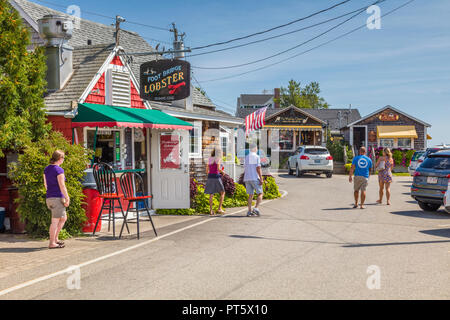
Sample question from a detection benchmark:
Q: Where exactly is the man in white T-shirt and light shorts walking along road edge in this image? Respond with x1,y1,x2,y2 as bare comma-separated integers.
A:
244,144,264,217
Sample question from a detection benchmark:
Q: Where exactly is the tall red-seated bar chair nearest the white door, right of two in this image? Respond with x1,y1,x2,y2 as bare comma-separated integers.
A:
119,172,158,239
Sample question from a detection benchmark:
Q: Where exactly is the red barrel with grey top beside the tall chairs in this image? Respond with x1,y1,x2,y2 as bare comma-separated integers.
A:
81,169,102,232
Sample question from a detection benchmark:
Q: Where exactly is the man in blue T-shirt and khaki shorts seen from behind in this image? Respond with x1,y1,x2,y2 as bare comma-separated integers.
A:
349,147,373,209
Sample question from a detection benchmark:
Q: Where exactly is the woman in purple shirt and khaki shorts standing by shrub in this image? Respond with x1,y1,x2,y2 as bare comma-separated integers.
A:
44,150,70,249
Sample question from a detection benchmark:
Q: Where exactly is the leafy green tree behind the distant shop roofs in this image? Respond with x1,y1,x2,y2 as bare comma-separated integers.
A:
275,79,329,109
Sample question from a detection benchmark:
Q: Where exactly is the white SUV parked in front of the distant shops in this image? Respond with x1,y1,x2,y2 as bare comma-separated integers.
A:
287,146,334,178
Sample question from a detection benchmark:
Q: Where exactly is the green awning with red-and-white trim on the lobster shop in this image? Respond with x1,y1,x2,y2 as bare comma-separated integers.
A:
72,103,193,130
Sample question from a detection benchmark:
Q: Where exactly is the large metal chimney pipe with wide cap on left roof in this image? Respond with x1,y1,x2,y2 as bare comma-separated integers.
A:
38,15,73,92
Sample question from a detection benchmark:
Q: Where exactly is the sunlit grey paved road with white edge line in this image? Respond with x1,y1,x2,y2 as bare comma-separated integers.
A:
0,175,450,299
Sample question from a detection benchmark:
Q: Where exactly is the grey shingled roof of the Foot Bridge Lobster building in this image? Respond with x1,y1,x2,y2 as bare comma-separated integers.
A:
11,0,215,111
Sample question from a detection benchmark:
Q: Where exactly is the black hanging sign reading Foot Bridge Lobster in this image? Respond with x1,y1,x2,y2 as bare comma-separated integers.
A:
141,60,191,102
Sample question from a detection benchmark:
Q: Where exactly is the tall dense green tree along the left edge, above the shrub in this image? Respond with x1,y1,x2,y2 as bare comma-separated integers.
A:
0,0,51,157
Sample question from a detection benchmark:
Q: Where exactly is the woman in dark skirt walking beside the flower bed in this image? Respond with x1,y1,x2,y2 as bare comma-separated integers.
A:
205,149,225,215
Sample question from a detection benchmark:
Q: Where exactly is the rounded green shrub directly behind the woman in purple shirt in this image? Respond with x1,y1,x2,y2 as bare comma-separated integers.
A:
10,131,90,237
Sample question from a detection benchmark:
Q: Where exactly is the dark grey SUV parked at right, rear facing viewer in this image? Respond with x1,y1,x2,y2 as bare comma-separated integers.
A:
411,150,450,211
